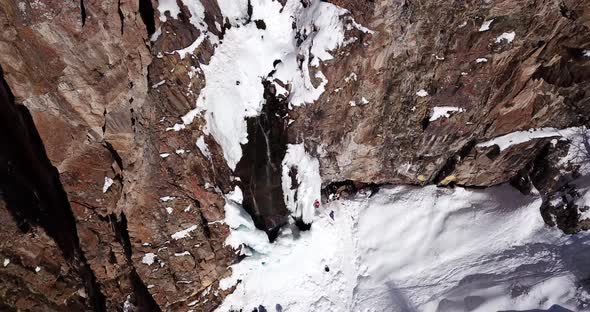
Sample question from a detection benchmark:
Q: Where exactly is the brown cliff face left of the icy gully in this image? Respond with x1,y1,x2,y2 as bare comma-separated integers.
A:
0,1,235,311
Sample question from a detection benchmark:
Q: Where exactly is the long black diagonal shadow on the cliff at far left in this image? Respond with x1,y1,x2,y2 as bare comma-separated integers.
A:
0,68,106,311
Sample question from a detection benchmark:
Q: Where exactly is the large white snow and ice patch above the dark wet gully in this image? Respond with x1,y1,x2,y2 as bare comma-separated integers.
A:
177,0,358,169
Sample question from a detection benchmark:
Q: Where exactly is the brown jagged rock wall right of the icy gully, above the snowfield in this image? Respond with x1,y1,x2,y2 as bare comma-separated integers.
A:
290,0,590,190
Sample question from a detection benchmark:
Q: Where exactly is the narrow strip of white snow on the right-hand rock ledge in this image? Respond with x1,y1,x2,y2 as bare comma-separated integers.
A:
477,128,577,151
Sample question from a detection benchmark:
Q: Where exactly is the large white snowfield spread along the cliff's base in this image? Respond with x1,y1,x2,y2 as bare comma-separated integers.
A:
217,185,590,312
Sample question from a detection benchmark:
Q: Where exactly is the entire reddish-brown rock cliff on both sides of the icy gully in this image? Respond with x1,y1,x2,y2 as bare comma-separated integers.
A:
0,0,590,311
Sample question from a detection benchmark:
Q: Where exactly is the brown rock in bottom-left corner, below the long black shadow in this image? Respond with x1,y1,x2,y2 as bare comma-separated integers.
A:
0,203,88,311
